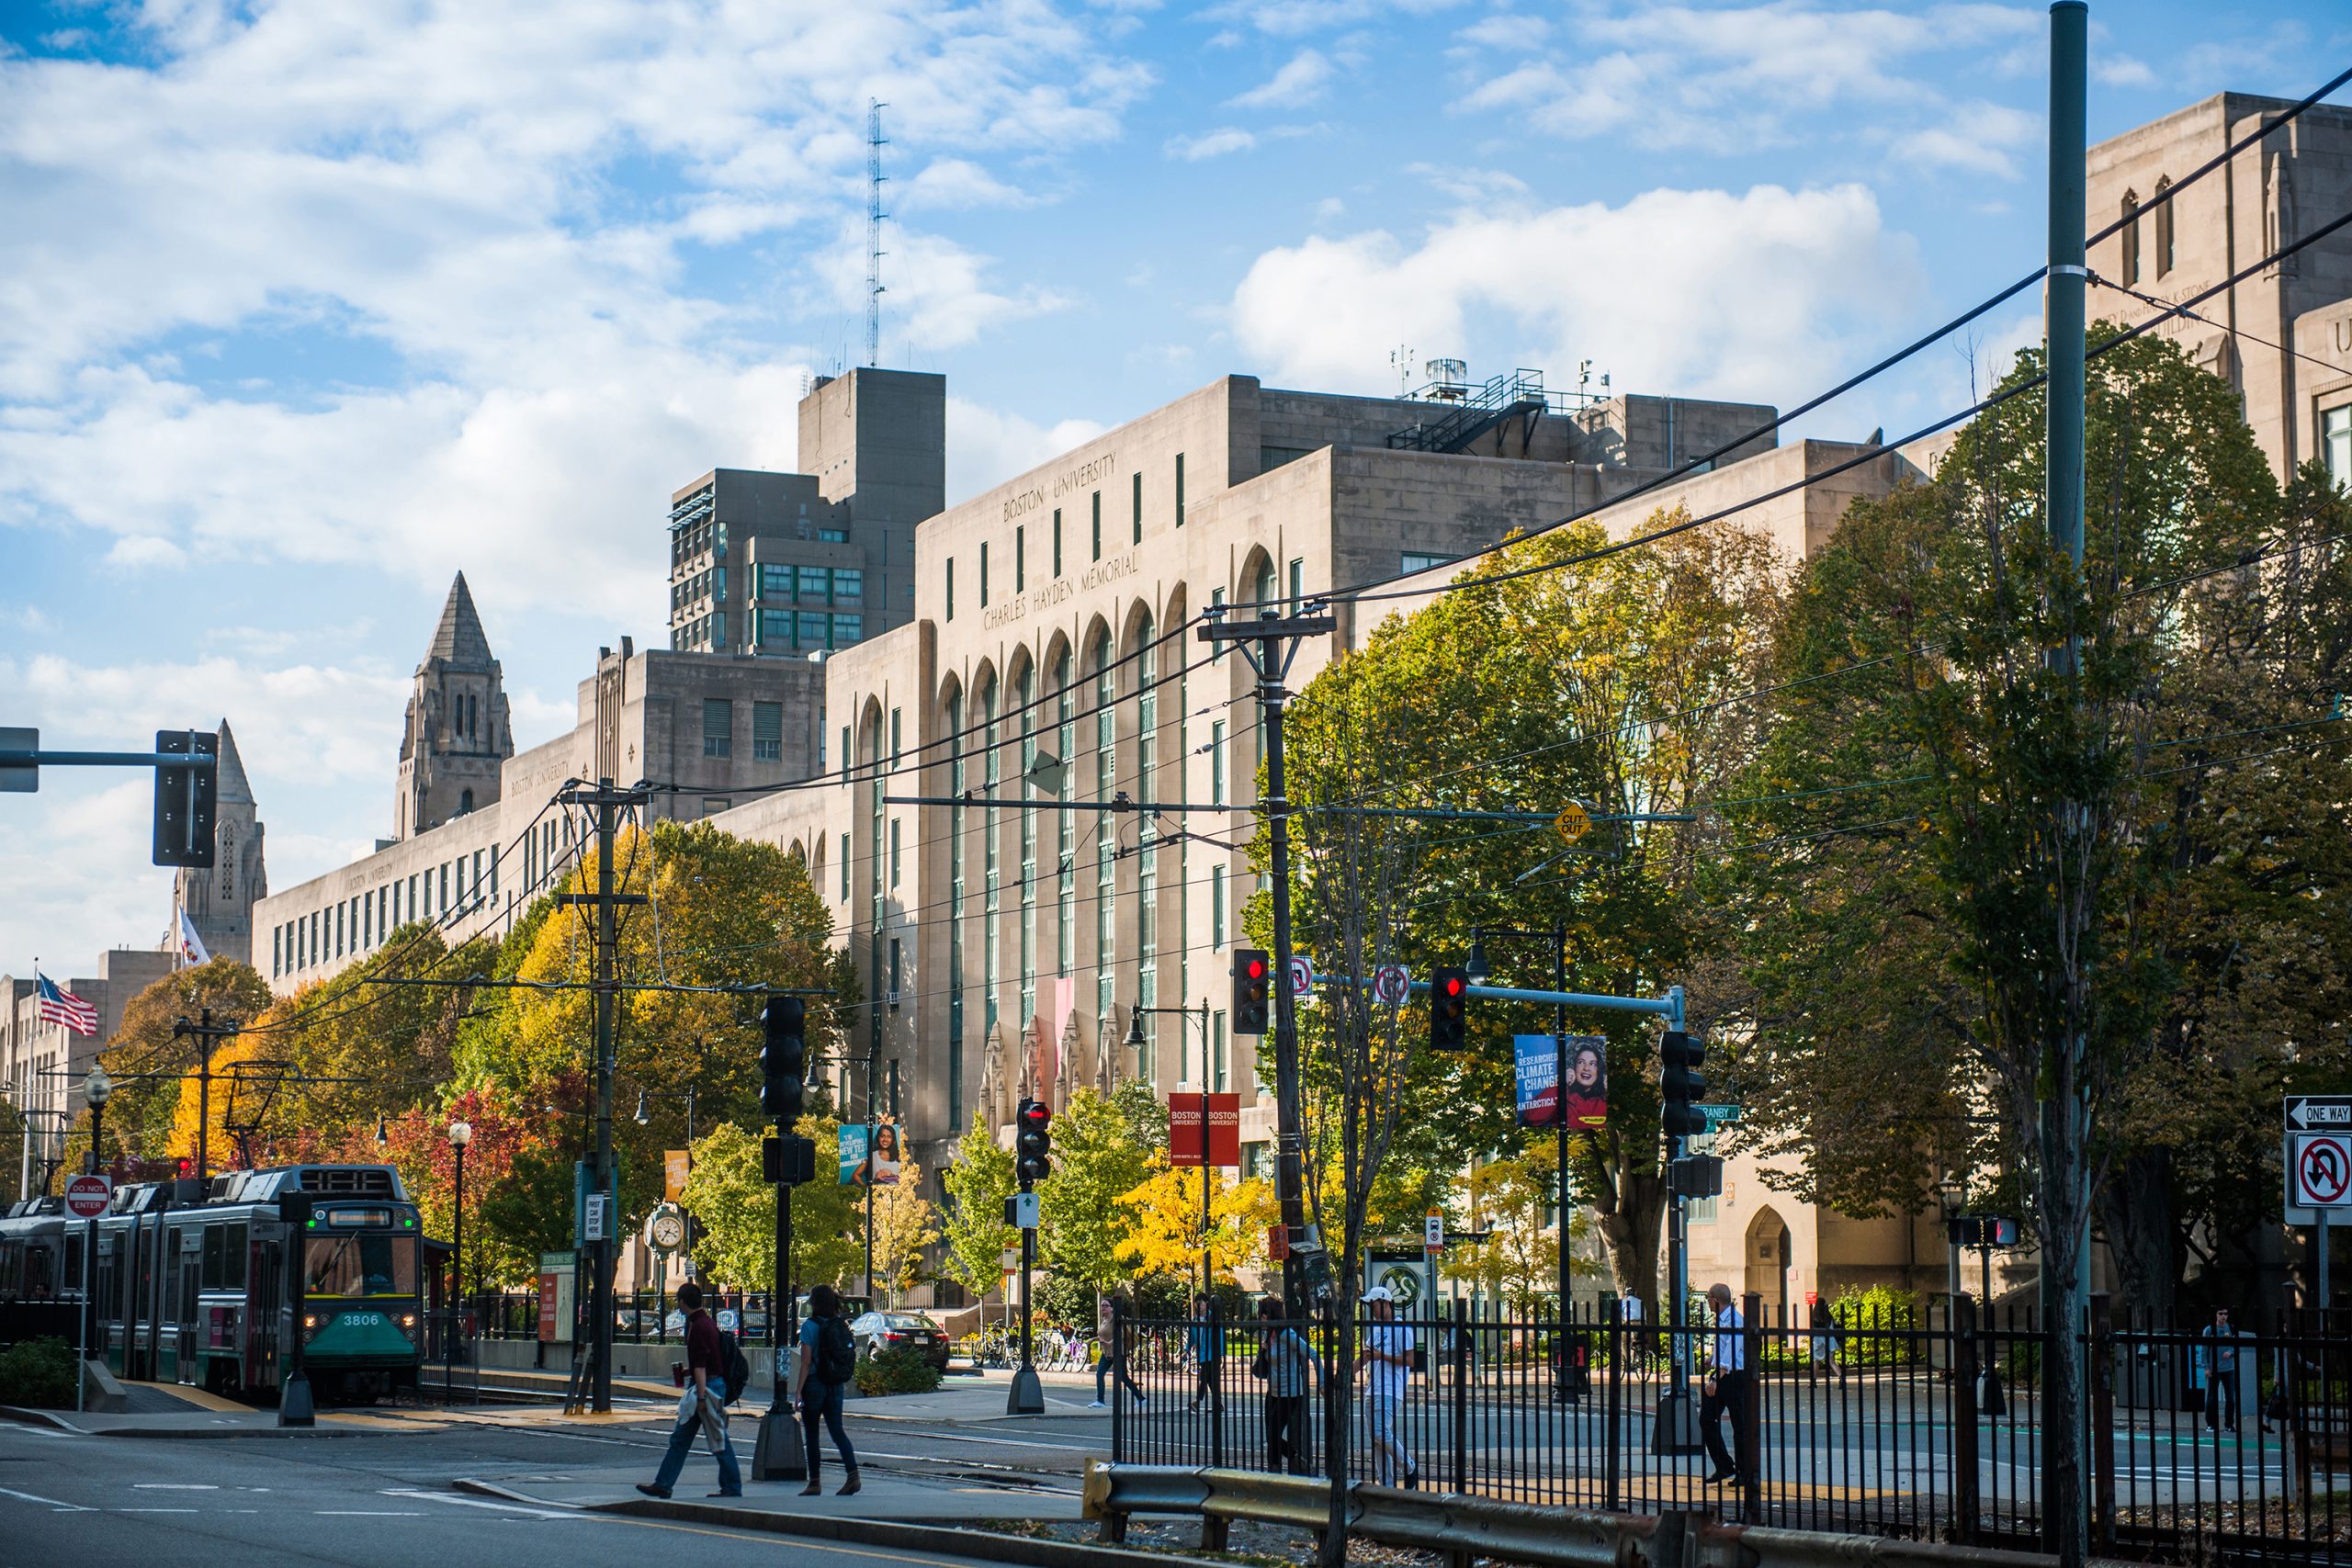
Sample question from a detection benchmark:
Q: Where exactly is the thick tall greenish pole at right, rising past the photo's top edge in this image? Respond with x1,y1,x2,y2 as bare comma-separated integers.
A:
2041,12,2091,1568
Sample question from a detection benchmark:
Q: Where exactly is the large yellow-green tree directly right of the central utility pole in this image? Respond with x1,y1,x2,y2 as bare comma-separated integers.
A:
1288,514,1782,1298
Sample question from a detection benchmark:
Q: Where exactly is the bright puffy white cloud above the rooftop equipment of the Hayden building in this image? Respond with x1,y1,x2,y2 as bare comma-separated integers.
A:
1230,186,1922,402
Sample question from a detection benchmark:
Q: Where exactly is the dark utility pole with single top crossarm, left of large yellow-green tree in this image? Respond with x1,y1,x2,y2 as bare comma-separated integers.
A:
1200,604,1339,1316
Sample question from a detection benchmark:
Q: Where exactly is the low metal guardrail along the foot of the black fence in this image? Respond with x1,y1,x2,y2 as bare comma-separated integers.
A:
1084,1462,2051,1568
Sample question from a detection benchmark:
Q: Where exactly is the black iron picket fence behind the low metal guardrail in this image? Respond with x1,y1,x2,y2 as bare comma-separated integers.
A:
1099,1298,2352,1563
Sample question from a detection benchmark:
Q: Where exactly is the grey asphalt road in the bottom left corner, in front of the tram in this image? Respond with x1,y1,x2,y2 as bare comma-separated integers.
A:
0,1422,1068,1568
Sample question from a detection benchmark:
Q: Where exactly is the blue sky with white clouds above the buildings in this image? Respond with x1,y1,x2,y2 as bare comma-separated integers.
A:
0,0,2352,974
